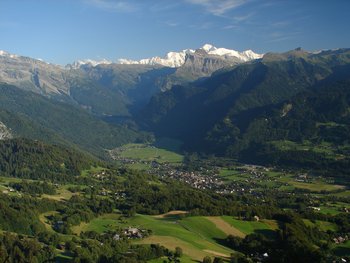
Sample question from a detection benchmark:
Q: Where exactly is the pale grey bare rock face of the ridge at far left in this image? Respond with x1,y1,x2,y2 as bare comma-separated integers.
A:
0,51,69,95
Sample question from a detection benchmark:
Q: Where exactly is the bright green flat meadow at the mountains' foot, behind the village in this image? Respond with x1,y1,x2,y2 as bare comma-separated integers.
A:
119,143,183,163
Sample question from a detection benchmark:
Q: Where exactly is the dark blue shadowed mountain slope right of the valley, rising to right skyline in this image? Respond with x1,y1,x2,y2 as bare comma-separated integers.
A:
139,49,350,157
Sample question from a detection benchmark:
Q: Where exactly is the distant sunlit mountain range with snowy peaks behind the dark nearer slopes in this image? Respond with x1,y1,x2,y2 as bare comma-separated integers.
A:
0,44,262,117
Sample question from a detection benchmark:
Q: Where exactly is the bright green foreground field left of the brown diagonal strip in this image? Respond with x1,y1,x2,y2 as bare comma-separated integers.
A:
72,215,234,262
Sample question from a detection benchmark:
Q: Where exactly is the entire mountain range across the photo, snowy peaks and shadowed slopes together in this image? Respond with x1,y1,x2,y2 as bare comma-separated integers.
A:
0,44,350,175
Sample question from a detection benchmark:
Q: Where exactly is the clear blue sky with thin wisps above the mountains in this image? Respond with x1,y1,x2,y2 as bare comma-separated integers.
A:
0,0,350,65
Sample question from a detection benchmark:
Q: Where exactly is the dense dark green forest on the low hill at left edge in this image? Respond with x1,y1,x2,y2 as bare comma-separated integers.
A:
0,139,97,181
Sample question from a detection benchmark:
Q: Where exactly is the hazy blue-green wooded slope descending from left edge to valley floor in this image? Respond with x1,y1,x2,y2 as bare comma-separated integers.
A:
0,84,147,156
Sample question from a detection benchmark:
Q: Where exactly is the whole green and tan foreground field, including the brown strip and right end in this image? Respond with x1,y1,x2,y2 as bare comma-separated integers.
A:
72,212,277,262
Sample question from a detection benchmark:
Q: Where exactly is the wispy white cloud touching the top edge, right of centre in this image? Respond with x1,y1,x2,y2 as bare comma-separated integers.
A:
185,0,247,16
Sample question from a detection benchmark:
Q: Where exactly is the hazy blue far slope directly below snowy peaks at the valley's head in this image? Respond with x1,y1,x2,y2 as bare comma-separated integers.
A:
70,64,174,116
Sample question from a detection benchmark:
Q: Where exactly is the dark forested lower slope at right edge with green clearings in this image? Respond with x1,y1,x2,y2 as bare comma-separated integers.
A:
238,80,350,177
